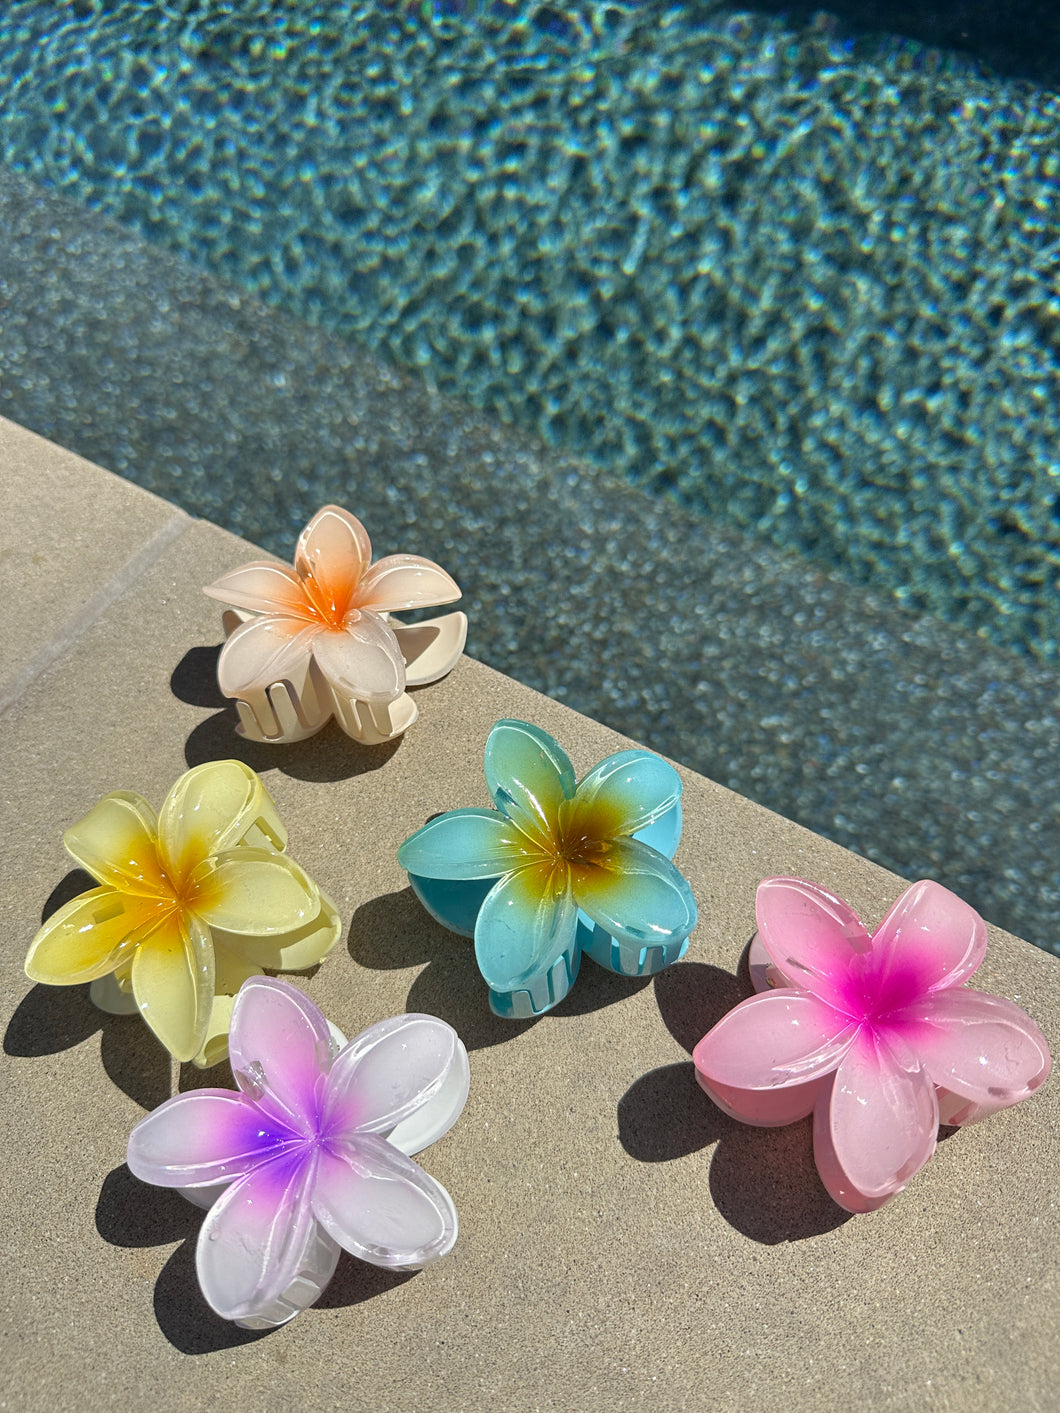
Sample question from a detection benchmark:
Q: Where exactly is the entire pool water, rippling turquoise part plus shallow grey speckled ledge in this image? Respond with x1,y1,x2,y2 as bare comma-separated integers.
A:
0,0,1060,944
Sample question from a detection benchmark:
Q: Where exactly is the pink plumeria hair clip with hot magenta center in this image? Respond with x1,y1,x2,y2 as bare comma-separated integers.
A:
693,877,1052,1212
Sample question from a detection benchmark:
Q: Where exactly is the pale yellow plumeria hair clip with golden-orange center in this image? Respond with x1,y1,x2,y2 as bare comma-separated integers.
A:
25,760,341,1065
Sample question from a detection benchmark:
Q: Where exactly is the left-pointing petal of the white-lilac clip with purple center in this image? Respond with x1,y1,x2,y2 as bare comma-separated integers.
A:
127,1089,299,1187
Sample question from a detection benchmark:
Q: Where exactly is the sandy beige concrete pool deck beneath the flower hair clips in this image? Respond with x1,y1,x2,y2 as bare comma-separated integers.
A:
0,421,1060,1413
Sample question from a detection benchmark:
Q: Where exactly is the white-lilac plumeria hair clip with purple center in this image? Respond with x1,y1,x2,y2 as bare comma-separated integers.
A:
129,976,468,1330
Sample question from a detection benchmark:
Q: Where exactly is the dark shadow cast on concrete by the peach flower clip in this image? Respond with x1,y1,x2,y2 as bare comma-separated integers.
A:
170,643,401,784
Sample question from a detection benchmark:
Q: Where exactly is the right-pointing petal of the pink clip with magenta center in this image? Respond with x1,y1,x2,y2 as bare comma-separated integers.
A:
902,986,1052,1123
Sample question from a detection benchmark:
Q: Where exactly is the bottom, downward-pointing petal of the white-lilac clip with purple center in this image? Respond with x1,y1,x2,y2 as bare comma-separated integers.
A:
195,1152,317,1320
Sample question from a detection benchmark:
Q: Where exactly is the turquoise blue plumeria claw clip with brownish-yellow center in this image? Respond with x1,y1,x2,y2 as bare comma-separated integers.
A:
397,721,697,1020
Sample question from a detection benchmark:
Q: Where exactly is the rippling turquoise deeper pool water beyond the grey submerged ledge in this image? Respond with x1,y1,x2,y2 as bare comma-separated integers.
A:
0,0,1060,661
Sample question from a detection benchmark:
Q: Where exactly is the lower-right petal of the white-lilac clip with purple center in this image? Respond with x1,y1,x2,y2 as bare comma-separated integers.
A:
312,1133,457,1267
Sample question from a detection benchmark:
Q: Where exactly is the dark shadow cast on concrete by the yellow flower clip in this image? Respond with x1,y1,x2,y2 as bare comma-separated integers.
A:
4,869,170,1109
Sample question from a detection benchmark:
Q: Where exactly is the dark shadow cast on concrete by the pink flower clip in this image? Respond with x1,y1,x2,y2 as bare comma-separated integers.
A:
618,950,849,1245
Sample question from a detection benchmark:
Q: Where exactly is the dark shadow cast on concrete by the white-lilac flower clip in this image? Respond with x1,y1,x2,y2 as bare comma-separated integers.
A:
96,1163,417,1354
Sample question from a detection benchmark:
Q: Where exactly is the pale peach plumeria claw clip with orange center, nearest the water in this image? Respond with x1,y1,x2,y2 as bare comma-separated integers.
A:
204,506,468,746
